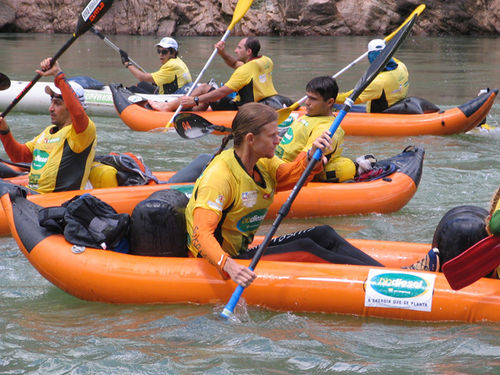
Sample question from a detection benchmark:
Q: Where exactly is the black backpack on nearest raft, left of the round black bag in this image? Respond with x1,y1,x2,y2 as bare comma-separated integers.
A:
38,193,130,252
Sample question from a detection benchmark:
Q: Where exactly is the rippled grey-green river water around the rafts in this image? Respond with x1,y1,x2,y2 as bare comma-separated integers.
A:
0,33,500,374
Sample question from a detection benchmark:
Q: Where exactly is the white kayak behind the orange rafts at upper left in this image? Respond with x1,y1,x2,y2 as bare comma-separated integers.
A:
0,78,180,117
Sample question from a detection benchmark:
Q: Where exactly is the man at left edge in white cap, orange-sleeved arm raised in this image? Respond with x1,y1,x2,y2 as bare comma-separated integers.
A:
0,58,97,193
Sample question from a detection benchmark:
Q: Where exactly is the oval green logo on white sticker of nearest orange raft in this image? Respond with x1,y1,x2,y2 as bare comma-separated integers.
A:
369,273,429,298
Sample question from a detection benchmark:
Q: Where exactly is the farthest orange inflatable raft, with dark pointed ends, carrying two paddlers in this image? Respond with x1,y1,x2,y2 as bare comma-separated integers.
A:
110,84,498,136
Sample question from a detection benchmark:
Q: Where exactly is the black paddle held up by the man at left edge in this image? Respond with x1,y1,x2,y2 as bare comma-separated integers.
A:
0,0,113,117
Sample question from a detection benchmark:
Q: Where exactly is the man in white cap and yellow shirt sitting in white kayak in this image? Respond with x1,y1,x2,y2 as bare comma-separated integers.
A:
120,37,192,94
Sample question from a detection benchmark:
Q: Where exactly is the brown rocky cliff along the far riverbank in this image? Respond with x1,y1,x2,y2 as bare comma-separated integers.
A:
0,0,500,36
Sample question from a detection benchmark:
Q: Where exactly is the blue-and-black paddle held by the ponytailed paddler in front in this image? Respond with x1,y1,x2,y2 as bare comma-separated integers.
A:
220,8,418,319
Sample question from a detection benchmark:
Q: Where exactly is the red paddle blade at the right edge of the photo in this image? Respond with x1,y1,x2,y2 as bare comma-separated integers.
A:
441,236,500,290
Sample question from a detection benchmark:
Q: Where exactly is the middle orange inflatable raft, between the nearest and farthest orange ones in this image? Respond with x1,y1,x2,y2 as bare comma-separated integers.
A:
0,146,425,235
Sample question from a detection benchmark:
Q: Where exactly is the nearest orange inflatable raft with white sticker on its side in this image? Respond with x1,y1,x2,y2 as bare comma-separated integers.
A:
1,194,500,322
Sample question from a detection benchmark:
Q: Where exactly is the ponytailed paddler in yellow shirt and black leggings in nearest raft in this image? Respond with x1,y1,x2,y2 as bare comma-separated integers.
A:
186,103,382,287
